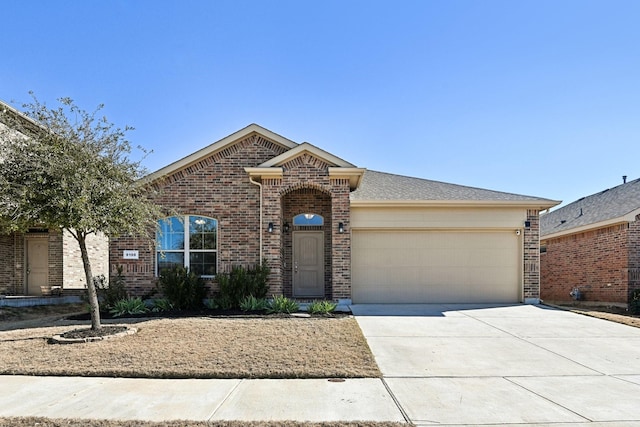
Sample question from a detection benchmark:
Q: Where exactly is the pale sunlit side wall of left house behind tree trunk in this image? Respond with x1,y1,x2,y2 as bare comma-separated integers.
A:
62,231,109,289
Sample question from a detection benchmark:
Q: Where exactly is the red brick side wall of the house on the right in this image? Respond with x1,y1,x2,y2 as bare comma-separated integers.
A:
540,222,640,304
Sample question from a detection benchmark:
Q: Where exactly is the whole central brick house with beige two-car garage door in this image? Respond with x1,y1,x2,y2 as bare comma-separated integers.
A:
110,124,559,303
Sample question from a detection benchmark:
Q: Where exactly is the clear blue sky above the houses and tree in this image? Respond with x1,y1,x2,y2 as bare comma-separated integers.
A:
0,0,640,207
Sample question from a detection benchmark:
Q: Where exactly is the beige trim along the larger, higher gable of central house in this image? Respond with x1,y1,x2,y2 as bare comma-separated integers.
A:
144,123,298,181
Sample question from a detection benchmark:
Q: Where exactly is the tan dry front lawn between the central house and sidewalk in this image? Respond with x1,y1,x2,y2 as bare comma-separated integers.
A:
0,317,381,378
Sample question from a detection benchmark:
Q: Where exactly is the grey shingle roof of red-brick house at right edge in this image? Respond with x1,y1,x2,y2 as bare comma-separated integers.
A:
540,179,640,238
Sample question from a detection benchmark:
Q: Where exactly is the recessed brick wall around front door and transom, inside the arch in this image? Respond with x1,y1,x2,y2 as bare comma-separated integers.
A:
281,184,333,299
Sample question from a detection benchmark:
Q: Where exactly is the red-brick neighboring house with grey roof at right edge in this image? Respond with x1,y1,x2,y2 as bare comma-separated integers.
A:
540,177,640,305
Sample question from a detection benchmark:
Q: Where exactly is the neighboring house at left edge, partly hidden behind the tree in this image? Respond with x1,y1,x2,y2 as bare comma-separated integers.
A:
0,101,109,296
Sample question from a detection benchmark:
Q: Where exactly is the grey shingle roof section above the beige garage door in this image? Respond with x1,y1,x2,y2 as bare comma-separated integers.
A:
351,170,560,209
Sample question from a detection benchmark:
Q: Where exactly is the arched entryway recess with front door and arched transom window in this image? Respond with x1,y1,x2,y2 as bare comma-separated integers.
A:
281,188,332,300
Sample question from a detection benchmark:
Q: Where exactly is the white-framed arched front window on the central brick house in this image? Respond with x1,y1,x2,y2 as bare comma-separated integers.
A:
156,215,218,278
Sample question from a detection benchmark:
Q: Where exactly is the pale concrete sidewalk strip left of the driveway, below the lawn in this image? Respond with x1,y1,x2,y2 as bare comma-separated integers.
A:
0,376,404,422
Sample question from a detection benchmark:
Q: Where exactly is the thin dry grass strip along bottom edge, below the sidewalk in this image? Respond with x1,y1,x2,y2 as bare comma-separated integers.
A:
0,417,408,427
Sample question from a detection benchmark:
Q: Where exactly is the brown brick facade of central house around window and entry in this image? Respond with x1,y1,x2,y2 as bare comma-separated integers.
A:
110,135,351,299
